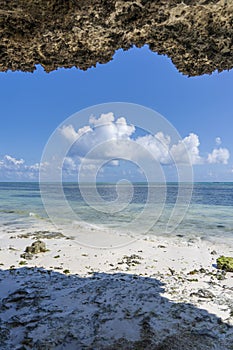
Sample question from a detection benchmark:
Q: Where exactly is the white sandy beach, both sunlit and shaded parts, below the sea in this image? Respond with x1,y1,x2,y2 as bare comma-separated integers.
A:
0,230,233,350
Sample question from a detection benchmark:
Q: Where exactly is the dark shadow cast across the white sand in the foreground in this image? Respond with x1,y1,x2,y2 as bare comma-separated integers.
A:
0,267,233,350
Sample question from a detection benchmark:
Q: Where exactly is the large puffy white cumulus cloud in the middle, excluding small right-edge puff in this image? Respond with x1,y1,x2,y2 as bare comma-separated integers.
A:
61,113,204,164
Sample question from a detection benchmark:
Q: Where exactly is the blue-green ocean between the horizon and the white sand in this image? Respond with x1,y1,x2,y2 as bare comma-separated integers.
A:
0,182,233,242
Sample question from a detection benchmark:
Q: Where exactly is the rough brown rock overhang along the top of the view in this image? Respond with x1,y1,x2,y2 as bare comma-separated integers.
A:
0,0,233,76
